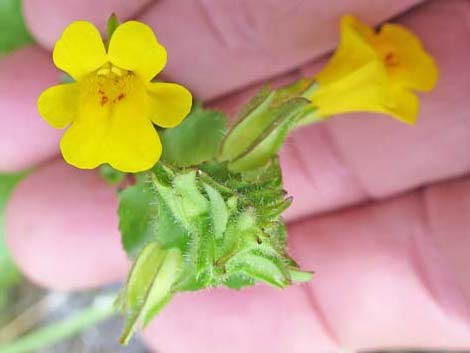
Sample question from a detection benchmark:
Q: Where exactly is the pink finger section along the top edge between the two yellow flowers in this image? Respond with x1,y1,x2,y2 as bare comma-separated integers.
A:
141,0,420,100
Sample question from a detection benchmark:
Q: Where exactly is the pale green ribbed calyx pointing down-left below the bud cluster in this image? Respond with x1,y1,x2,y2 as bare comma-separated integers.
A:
119,242,183,344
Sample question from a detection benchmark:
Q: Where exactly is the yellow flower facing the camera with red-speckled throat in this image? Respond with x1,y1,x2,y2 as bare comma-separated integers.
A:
38,21,192,172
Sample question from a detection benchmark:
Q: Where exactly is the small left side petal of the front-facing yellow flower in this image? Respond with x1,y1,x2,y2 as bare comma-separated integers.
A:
38,83,79,129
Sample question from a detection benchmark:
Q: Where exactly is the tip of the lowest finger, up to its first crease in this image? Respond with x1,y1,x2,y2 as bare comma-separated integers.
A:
143,285,336,353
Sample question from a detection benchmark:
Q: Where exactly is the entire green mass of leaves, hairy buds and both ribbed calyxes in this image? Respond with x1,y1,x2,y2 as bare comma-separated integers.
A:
118,83,318,343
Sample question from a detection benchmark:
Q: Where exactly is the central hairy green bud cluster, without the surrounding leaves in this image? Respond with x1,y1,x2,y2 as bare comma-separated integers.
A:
153,161,304,290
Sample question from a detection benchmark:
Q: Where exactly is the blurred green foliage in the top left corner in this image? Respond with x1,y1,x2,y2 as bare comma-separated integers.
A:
0,0,33,54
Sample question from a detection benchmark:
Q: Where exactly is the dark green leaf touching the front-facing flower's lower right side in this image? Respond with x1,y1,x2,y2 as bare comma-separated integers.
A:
161,104,226,167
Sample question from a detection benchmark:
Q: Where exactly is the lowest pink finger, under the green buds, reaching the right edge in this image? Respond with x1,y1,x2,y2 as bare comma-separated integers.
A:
144,179,470,353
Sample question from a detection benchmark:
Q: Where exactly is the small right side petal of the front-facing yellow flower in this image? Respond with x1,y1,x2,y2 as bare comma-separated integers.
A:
147,82,192,128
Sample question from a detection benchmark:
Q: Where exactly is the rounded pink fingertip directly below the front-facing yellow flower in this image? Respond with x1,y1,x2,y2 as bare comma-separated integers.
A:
5,160,129,290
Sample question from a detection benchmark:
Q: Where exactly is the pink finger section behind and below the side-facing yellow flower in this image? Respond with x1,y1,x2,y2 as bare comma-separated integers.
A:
213,1,470,219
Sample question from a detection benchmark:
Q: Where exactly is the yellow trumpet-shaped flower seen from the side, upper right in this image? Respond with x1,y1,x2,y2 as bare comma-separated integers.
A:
308,15,438,124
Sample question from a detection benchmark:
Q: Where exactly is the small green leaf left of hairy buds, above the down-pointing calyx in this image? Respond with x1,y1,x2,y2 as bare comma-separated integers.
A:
118,181,157,258
